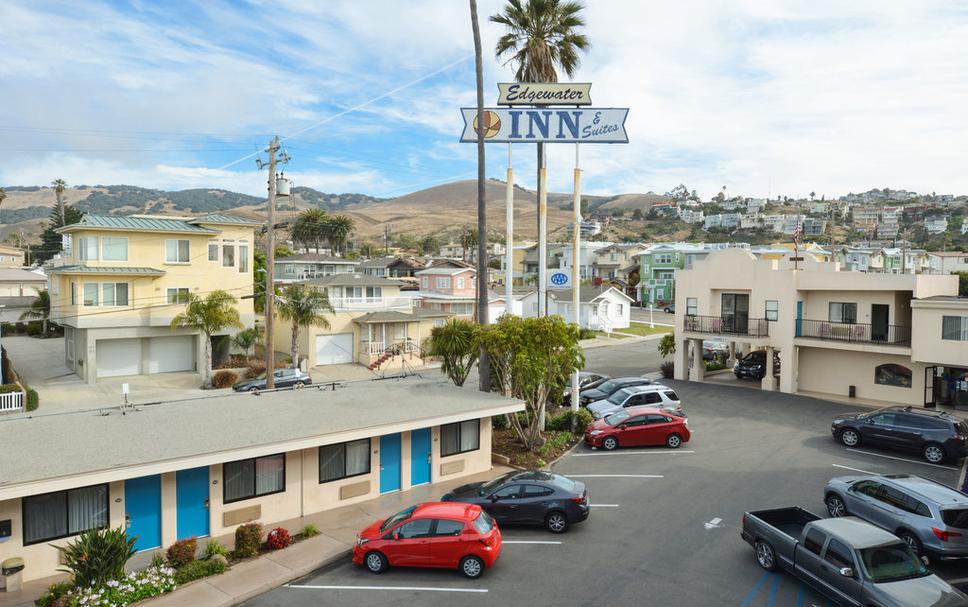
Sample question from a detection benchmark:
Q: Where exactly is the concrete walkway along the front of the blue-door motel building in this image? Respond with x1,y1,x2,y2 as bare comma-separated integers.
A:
0,465,511,607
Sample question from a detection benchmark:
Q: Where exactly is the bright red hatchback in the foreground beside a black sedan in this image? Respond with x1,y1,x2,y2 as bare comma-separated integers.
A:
353,502,501,579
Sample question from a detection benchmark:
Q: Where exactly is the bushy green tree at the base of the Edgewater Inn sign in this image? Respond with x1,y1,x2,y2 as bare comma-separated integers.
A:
480,314,585,449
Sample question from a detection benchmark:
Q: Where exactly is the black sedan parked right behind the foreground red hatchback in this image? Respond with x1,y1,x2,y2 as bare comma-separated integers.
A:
440,470,588,533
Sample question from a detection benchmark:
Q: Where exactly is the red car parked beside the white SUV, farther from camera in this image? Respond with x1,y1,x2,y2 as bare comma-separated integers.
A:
585,407,690,451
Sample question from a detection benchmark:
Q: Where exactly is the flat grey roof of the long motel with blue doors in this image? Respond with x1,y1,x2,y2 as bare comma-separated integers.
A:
0,376,524,501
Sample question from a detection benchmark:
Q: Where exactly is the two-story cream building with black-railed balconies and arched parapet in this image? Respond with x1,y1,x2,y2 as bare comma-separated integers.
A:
675,249,968,407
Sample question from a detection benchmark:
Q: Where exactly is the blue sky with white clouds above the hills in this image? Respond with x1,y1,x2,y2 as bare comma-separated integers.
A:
0,0,968,197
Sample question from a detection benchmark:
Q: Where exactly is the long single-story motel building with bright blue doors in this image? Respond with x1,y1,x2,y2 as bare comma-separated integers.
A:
0,378,524,581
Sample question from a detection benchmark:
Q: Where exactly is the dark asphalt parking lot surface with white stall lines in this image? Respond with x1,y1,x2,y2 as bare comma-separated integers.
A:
247,381,968,607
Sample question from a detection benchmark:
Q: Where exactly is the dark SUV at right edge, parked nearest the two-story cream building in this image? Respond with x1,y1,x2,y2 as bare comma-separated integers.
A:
830,407,968,464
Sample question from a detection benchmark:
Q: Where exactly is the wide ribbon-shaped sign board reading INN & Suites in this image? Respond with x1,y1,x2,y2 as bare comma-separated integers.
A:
460,108,629,143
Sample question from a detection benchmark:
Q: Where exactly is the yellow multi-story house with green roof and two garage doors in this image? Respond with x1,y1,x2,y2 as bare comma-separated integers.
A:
47,215,261,384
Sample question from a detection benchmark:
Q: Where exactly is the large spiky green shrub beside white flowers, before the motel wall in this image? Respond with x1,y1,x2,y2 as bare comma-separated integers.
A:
57,527,135,587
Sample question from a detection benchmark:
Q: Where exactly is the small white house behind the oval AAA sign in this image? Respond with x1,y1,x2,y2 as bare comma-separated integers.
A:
522,286,632,331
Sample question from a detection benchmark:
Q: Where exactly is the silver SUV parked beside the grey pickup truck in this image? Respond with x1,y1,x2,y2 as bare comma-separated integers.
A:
824,474,968,561
